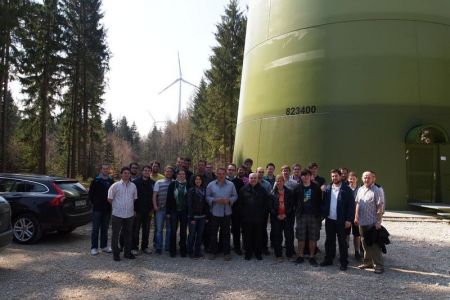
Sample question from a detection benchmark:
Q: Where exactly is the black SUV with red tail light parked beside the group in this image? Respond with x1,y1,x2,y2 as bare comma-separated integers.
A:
0,173,92,244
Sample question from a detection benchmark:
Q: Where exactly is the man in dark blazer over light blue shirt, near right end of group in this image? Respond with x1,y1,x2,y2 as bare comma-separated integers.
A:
320,169,355,271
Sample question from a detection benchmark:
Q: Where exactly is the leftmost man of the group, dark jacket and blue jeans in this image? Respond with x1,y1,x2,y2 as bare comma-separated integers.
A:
89,164,113,255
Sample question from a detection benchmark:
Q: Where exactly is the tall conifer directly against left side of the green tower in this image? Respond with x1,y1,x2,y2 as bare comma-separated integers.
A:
189,0,247,162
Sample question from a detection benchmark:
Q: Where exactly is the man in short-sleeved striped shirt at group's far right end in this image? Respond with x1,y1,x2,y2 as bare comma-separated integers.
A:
355,171,384,274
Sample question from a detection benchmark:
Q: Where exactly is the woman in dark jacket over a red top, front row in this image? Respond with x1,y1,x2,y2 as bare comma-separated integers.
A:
270,175,295,261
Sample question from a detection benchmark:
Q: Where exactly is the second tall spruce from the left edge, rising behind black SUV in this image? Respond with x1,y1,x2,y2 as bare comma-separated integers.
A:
20,0,63,174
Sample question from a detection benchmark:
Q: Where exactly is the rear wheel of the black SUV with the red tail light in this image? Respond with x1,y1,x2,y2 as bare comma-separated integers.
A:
13,214,42,244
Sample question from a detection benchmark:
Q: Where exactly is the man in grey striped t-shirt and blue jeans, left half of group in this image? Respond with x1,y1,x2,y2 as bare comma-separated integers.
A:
153,166,174,254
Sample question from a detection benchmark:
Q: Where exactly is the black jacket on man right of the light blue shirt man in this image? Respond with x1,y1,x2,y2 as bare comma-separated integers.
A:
239,183,270,223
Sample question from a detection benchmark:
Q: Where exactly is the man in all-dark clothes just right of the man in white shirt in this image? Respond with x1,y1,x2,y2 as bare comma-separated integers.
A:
131,166,155,255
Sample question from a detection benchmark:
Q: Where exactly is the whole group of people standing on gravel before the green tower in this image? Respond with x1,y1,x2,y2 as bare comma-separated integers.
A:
89,157,385,273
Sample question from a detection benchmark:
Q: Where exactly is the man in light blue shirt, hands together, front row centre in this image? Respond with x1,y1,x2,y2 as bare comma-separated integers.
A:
206,168,237,260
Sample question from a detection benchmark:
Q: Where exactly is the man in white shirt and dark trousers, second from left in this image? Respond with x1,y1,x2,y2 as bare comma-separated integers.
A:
108,167,137,261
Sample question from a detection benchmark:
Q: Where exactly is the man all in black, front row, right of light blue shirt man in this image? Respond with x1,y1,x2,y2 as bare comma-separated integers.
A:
239,173,269,260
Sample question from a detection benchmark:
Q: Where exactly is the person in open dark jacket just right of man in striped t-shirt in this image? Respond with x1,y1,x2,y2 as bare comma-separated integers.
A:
166,170,188,257
